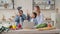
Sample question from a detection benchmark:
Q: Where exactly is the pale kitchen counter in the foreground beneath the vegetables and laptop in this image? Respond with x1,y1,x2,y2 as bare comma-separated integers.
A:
2,29,60,34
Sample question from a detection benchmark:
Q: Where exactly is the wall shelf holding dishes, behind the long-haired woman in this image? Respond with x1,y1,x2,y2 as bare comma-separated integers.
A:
33,0,55,10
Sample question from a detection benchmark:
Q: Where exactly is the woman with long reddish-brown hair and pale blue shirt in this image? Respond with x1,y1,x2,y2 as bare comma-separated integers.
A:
34,6,44,24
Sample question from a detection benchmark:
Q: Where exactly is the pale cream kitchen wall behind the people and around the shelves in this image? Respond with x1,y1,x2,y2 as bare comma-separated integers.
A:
0,0,60,19
